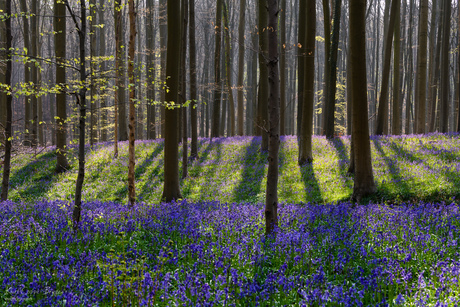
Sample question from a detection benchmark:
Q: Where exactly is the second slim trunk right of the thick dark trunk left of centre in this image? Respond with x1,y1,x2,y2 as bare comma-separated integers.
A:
189,0,198,159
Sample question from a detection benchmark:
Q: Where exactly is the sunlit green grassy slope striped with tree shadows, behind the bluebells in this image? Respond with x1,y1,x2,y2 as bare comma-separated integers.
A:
0,134,460,203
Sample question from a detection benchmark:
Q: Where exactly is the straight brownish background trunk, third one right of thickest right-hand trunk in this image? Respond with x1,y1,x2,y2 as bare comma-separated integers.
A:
414,0,428,134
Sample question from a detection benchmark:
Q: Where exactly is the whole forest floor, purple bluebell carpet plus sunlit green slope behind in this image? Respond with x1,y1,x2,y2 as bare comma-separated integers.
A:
0,134,460,306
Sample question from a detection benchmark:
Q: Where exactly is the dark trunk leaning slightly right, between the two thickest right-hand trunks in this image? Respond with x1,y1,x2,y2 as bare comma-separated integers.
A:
324,0,342,138
